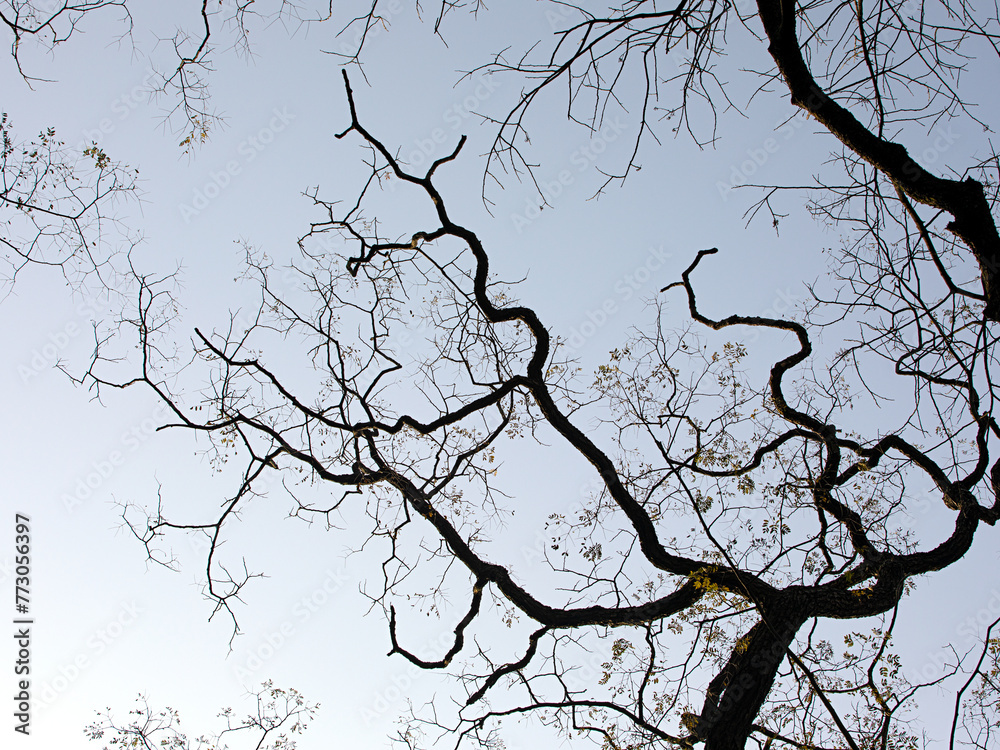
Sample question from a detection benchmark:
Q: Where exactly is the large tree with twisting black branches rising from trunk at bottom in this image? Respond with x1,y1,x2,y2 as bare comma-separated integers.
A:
68,63,1000,750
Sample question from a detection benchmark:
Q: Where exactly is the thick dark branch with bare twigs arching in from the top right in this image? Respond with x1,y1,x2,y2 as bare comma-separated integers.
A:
472,0,1000,321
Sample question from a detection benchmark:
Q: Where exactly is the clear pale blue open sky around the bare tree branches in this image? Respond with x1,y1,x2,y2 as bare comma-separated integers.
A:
0,2,1000,750
